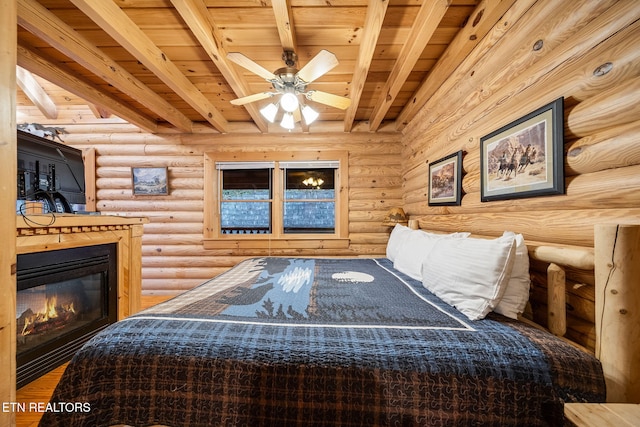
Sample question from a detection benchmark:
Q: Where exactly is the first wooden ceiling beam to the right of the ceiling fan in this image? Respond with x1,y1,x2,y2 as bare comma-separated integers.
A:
344,0,389,132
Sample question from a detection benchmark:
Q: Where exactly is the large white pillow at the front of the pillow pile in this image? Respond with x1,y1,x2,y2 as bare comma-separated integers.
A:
422,236,516,320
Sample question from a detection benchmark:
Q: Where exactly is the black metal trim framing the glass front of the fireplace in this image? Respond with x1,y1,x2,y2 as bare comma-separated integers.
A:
16,243,118,388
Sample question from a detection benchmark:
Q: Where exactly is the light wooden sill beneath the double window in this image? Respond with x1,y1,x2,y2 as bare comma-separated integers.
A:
203,235,349,249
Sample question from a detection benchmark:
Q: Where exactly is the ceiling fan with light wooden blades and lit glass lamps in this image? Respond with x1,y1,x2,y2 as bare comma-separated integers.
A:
227,49,351,130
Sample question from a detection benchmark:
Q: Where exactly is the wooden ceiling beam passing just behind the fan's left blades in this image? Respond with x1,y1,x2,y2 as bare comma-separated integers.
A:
171,0,269,133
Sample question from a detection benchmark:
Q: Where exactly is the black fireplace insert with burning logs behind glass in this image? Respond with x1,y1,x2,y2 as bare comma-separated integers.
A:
16,243,118,387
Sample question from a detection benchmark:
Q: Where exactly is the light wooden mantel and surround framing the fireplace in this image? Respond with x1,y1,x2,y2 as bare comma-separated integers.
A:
16,214,149,319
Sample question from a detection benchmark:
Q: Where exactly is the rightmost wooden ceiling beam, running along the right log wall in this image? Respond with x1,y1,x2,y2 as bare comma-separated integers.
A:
396,0,515,130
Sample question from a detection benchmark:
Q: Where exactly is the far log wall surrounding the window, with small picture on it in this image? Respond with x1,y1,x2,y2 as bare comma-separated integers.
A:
65,132,402,295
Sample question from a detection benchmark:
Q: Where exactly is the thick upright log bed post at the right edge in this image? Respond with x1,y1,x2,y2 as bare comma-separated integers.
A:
594,225,640,403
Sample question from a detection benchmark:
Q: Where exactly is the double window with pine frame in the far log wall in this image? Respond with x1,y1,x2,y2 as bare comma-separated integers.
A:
204,152,348,248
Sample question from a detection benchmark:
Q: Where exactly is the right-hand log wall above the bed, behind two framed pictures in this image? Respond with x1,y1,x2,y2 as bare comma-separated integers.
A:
402,0,640,348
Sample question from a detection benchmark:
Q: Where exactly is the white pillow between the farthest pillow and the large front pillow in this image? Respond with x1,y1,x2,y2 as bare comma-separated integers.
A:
393,230,447,280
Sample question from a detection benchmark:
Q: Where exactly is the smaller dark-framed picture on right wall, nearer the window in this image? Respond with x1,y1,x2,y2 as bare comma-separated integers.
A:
428,150,463,206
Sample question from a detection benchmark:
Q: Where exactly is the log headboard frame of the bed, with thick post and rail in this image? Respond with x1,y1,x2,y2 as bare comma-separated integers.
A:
440,224,640,403
